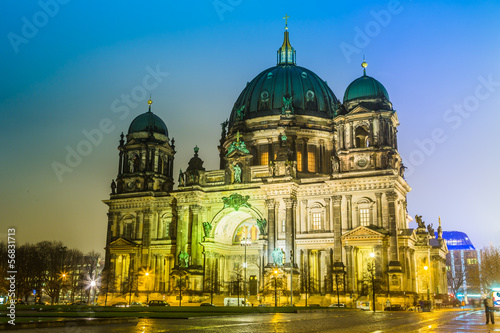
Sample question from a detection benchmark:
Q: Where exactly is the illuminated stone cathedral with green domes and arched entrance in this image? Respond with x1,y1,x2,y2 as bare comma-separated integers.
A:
104,24,447,303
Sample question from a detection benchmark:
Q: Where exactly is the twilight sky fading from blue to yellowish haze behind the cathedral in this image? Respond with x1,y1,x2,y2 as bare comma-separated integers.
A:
0,0,500,253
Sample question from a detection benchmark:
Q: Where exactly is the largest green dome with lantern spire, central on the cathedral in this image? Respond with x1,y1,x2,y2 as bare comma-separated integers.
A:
229,30,339,126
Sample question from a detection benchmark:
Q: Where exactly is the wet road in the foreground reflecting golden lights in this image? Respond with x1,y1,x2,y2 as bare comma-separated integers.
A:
13,310,500,333
